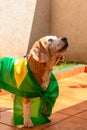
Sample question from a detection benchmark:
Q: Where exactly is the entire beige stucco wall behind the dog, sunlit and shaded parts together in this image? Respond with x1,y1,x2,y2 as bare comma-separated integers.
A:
0,0,87,62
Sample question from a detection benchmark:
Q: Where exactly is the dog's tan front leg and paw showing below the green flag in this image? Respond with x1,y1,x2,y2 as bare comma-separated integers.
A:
23,98,33,127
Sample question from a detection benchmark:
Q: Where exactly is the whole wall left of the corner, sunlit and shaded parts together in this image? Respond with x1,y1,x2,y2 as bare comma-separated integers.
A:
0,0,50,56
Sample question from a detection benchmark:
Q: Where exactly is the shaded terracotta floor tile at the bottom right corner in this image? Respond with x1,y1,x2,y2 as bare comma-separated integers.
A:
45,117,87,130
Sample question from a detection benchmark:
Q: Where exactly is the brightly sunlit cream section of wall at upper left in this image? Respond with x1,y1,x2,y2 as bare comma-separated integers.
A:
0,0,36,56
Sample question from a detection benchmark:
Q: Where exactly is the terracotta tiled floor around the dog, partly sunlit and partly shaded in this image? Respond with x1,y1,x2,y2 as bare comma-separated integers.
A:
0,72,87,130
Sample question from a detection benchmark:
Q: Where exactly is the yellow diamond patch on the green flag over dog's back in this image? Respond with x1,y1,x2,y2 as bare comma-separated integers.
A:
14,58,28,87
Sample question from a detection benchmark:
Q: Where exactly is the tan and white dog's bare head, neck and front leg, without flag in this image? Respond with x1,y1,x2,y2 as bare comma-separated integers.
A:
0,36,68,127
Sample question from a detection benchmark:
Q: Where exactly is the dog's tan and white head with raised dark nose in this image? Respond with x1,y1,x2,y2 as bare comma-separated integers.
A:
30,36,68,63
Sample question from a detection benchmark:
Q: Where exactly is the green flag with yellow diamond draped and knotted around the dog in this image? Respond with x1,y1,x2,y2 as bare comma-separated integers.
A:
0,57,59,125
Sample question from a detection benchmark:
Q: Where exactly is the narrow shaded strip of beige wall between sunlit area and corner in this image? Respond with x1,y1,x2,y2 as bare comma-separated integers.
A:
28,0,51,50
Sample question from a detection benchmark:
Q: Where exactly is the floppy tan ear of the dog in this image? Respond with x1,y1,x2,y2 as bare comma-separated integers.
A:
30,40,50,63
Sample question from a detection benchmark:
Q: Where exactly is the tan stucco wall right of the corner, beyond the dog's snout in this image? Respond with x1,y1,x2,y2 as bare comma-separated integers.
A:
51,0,87,62
